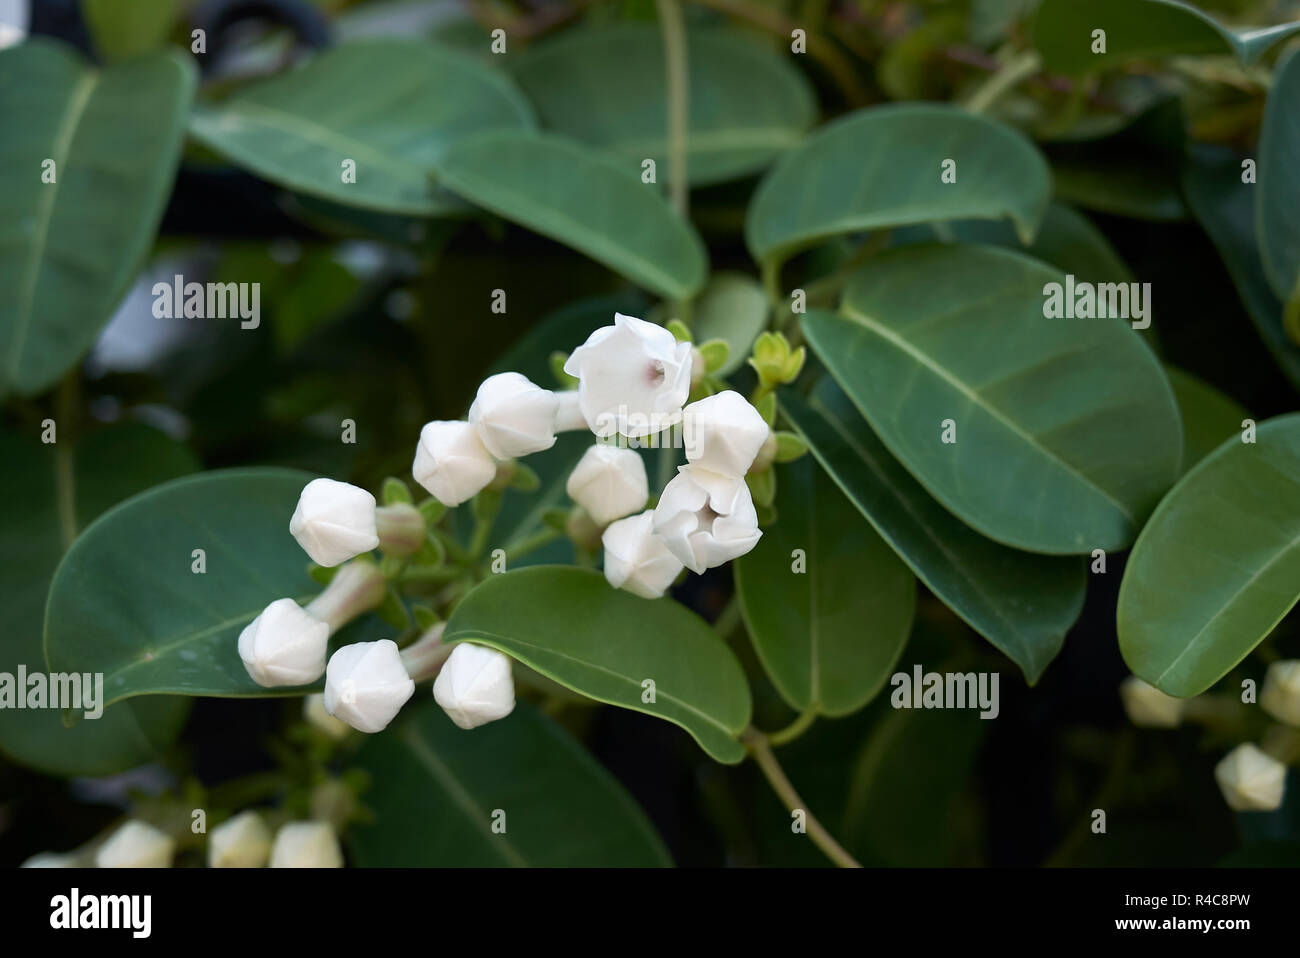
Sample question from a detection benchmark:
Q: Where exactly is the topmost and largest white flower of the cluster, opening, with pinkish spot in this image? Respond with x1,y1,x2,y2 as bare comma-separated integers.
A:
564,313,690,438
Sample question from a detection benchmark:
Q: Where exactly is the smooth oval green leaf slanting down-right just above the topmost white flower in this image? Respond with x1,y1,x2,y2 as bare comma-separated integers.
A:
437,130,707,299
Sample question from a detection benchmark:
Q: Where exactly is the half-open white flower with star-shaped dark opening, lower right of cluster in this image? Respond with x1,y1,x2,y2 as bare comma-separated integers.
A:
654,465,763,575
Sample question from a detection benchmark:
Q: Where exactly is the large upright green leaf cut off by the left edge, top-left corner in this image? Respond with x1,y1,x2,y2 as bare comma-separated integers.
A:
0,38,195,395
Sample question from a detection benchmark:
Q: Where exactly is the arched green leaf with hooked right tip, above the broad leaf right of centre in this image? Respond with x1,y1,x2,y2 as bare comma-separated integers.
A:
745,104,1050,270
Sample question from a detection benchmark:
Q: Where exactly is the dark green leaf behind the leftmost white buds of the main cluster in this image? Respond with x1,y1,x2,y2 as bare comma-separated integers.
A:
46,469,358,703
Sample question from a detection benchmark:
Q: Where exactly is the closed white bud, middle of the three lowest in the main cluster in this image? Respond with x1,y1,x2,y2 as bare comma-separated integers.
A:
325,638,415,733
